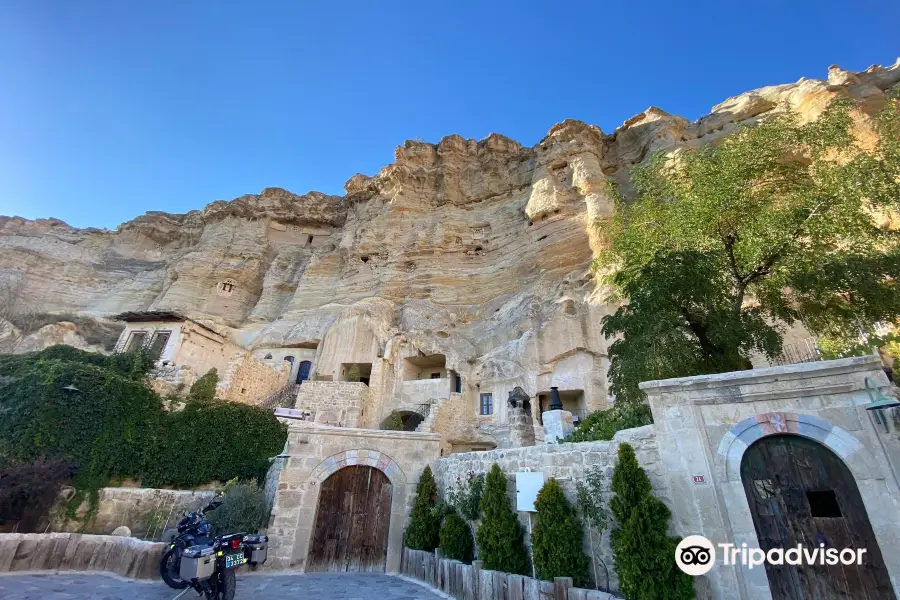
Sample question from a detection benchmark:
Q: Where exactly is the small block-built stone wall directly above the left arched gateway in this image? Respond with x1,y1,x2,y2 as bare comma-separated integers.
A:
294,381,377,427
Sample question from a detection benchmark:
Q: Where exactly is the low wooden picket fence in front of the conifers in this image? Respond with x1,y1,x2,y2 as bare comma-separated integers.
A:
400,548,619,600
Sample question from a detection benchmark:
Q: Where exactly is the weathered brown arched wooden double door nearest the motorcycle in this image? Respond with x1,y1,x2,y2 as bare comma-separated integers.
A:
307,466,393,572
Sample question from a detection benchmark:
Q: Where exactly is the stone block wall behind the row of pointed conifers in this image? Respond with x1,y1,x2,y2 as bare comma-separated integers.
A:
432,425,673,590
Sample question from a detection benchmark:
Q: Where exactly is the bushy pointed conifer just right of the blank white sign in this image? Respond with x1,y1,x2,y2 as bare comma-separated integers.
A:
531,477,590,587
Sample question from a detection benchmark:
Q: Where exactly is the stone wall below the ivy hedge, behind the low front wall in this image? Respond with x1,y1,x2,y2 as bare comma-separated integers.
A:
50,488,216,540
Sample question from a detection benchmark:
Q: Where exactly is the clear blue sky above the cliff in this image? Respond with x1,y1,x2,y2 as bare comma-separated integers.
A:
0,0,900,228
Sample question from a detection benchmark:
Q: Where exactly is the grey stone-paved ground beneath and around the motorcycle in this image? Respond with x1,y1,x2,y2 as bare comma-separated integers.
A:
0,573,441,600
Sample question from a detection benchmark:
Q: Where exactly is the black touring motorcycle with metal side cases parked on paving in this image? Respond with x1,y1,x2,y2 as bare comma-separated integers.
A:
179,533,269,600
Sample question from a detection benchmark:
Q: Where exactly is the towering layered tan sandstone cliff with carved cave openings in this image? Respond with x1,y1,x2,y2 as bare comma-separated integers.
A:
0,61,900,447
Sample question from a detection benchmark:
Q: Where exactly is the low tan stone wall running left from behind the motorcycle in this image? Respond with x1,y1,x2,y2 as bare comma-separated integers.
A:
0,533,166,579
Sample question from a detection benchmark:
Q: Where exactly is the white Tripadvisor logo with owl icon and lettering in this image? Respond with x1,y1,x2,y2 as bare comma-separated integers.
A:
675,535,866,577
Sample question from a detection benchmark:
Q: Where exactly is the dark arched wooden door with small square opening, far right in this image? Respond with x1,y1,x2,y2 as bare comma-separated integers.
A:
741,435,896,600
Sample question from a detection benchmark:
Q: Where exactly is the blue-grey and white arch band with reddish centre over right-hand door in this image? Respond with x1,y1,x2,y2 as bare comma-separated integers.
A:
715,412,883,483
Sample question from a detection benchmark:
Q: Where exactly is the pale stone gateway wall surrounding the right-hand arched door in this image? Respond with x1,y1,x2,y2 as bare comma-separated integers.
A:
641,356,900,600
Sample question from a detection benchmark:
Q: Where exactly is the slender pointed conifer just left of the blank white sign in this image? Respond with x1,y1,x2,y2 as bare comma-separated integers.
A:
475,464,529,575
